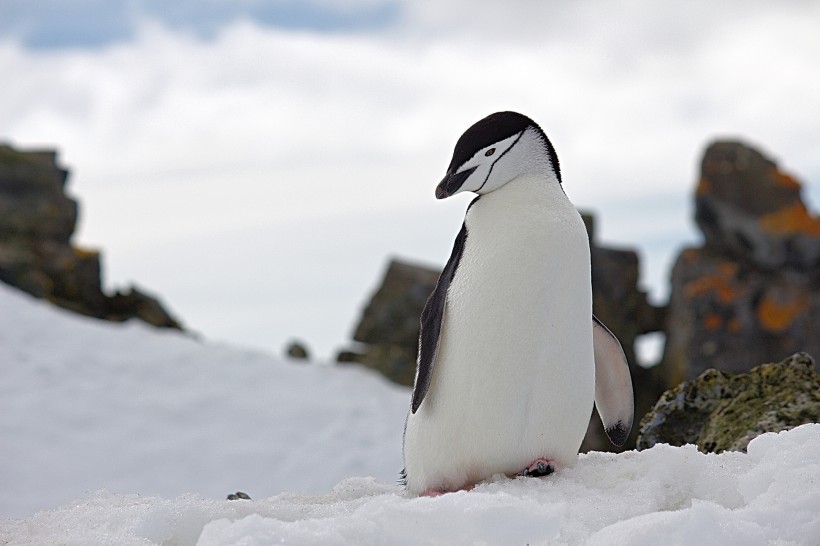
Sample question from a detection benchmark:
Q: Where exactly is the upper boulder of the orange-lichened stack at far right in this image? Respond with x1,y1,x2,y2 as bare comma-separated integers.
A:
695,142,820,271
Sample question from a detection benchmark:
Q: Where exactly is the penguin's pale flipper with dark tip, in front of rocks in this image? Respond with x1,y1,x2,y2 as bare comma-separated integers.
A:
592,315,634,446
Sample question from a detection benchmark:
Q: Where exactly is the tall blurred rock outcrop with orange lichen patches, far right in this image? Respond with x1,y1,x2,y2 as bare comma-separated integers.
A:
664,142,820,386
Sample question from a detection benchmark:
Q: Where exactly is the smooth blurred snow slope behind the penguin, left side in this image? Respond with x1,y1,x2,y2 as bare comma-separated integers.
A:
0,283,410,516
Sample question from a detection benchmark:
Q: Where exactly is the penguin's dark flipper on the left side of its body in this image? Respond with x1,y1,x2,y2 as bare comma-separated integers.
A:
412,224,467,413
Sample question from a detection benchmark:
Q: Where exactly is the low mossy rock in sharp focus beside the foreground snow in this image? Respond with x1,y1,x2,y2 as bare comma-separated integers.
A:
637,353,820,453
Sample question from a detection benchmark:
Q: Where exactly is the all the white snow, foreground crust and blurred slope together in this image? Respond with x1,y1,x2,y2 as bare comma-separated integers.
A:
0,285,820,546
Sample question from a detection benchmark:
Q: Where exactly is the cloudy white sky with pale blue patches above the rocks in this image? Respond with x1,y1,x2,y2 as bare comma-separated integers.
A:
0,0,820,357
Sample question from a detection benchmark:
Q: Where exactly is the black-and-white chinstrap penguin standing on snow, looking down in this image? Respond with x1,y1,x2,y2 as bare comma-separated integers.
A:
402,112,633,495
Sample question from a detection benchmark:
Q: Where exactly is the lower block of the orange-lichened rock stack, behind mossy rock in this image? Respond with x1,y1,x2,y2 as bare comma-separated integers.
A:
664,249,820,385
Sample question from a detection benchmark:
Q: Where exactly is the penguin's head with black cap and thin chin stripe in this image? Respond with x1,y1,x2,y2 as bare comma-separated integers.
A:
436,112,561,199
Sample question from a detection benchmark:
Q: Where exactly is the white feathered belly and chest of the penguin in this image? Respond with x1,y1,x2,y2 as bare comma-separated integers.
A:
405,177,595,493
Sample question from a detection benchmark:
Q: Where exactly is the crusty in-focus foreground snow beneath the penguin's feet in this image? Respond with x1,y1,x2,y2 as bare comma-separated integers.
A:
0,424,820,546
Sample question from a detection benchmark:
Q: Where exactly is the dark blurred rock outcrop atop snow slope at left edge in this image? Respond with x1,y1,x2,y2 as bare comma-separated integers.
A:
0,145,181,329
